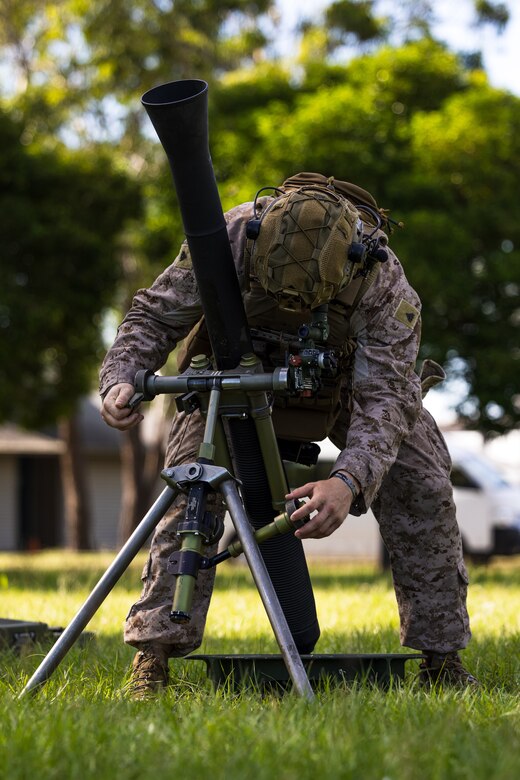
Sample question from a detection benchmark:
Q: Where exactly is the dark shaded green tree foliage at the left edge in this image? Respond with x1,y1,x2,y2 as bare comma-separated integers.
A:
0,108,140,427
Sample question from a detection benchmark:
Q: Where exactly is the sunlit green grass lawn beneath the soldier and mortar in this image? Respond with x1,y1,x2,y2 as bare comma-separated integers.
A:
0,552,520,780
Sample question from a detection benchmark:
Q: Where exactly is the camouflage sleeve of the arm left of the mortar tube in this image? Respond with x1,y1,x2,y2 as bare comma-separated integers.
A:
100,244,202,395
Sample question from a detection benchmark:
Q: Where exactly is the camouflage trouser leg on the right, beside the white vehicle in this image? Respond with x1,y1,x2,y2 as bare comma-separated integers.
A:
372,409,471,653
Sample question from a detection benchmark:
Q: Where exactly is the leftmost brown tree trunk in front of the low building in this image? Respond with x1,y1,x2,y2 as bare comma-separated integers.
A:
59,412,91,550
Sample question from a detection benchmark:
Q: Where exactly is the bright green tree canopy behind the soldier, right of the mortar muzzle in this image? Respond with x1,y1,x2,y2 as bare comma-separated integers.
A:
210,38,520,431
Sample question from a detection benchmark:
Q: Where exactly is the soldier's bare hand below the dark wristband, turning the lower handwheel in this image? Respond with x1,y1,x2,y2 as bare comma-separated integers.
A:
285,477,353,539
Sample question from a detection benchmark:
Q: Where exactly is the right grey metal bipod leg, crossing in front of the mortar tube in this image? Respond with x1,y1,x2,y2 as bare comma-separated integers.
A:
220,479,314,700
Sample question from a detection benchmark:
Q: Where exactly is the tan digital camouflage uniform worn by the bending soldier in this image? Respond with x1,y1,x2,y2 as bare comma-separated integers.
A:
100,203,470,656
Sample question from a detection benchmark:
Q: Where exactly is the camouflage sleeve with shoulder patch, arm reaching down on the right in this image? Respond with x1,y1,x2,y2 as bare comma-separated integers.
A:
331,250,422,514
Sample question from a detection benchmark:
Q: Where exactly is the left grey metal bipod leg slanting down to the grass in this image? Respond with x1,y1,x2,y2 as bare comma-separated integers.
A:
18,486,178,698
